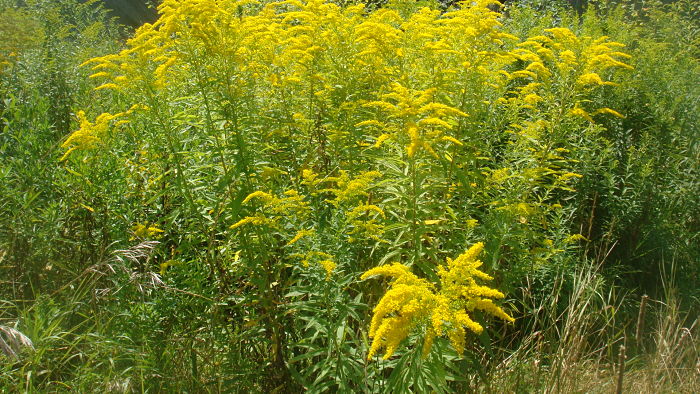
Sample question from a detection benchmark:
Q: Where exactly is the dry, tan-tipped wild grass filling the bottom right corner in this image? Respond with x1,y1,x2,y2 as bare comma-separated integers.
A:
481,260,700,393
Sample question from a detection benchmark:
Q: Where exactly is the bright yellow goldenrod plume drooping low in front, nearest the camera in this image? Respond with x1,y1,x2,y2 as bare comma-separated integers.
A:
361,243,514,359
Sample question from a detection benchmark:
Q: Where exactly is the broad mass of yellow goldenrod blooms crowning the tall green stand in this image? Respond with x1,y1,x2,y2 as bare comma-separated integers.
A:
66,0,630,174
